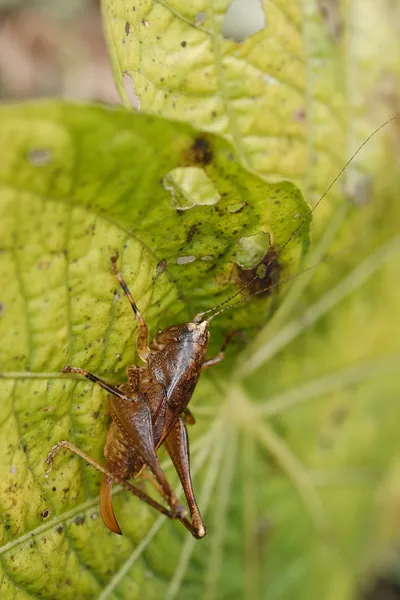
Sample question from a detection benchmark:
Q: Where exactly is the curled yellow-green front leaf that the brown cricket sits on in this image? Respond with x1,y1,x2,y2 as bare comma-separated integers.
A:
0,103,309,599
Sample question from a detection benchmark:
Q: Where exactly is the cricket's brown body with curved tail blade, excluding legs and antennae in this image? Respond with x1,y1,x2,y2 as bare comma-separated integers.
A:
100,321,209,537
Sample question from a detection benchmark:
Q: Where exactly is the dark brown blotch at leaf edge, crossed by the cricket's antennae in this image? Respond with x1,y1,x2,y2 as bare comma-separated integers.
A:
235,246,281,298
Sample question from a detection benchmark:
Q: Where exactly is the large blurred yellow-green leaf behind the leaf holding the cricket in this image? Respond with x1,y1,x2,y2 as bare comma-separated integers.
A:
103,0,400,600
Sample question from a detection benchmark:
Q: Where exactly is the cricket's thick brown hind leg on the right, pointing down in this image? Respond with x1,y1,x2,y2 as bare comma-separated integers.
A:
165,419,207,539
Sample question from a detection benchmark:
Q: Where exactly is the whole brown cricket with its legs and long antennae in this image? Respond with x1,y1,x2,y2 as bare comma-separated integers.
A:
46,117,396,539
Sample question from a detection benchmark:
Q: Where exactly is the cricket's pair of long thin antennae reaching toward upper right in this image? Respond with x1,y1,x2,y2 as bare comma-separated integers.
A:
194,116,397,323
